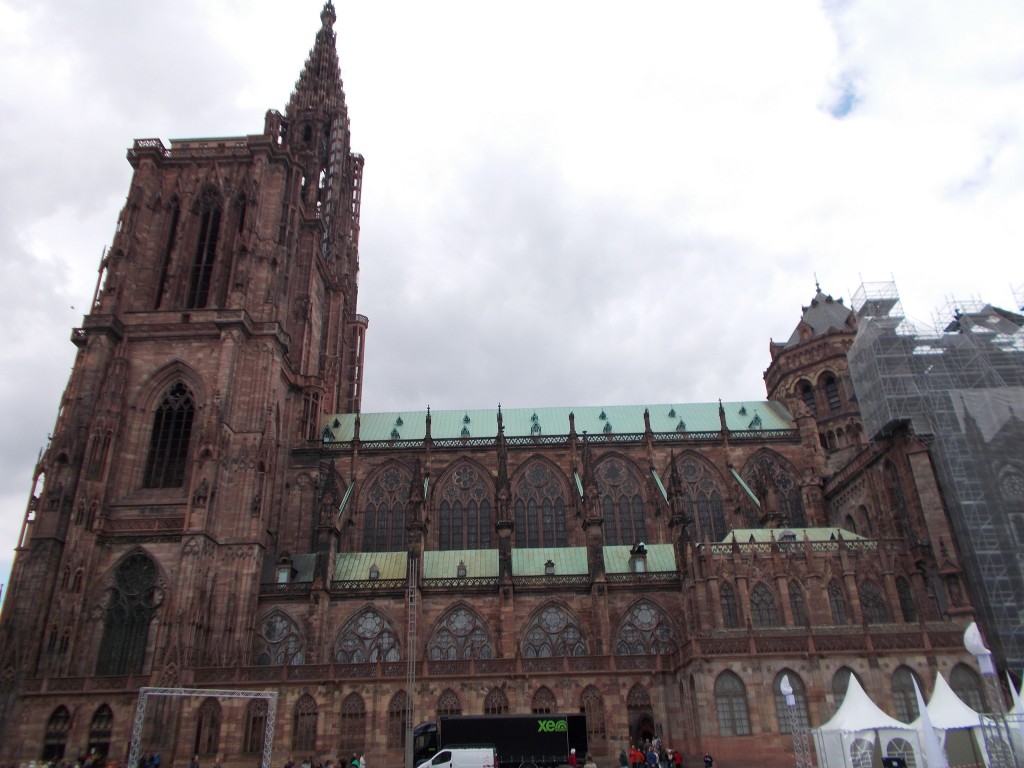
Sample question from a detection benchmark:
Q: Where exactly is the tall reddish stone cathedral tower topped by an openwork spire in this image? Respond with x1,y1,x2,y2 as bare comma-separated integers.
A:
0,0,368,740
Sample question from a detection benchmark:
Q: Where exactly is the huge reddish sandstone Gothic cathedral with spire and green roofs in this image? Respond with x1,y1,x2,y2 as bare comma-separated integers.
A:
0,0,986,768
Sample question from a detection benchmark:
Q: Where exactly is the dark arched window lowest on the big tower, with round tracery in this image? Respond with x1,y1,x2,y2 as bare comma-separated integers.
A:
96,552,163,675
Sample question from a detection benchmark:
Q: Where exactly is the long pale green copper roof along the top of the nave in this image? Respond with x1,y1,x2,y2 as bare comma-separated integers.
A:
324,400,796,442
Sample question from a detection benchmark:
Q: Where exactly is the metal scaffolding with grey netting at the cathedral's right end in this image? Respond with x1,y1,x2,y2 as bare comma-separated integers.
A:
849,283,1024,668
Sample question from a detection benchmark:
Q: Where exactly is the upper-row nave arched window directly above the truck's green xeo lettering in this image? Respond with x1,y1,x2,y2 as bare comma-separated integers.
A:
512,459,568,547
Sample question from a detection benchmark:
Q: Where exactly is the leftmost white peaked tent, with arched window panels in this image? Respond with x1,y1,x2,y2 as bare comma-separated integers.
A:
813,675,922,768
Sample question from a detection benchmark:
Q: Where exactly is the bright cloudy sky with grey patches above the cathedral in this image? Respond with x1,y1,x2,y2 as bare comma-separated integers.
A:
0,0,1024,583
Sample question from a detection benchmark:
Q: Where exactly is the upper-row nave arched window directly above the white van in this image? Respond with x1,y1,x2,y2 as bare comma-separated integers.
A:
436,462,494,550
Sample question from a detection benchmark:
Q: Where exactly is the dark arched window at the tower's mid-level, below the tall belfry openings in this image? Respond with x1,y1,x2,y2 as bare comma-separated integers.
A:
142,381,196,488
